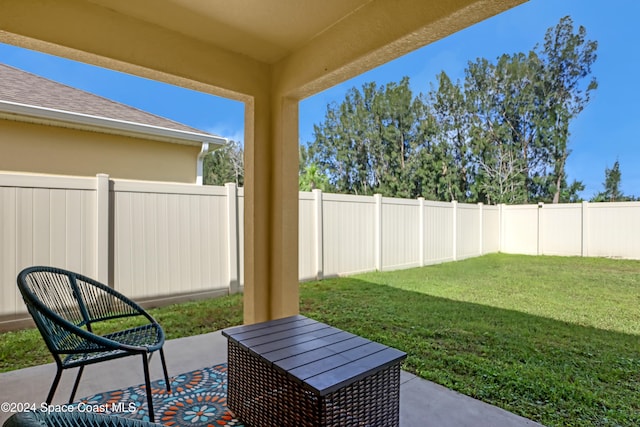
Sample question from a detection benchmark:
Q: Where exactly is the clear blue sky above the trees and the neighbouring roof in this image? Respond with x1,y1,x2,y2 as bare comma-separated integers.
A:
0,0,640,199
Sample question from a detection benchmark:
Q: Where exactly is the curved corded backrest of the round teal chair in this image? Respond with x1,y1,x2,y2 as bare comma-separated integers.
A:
17,266,142,354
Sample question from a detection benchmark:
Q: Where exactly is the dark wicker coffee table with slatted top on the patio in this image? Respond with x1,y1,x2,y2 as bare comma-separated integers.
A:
222,316,406,427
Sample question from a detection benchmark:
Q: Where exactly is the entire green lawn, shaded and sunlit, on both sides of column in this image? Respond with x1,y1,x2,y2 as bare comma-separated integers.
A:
0,254,640,426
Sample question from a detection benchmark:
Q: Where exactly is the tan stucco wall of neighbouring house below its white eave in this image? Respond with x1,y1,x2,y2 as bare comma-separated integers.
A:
0,120,200,183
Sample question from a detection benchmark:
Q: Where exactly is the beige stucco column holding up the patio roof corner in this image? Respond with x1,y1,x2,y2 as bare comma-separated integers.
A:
244,91,299,323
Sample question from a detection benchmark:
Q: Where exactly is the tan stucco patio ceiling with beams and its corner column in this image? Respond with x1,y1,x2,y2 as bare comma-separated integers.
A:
0,0,526,323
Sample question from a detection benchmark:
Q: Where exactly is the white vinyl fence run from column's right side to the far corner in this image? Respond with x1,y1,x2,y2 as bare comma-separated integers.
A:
298,195,500,280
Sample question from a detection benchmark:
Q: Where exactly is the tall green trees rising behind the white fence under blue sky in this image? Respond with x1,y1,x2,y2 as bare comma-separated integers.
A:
204,16,634,204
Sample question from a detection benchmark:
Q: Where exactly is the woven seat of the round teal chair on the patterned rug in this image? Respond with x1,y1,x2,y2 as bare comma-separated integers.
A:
62,323,163,368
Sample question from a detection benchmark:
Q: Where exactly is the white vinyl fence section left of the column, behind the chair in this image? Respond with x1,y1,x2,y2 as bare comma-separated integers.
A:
0,173,244,327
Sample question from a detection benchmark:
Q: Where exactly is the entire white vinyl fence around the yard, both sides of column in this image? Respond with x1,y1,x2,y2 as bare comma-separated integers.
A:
0,173,640,328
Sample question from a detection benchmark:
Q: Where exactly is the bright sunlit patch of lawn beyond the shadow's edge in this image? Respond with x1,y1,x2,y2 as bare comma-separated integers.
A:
350,254,640,335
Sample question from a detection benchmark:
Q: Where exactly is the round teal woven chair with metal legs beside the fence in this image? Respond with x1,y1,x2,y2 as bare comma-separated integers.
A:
17,266,171,422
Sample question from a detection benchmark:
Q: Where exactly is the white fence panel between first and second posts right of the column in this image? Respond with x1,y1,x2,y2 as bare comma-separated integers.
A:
322,194,376,277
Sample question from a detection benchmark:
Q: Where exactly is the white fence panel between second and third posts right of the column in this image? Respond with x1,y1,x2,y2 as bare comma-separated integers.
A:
381,197,420,270
